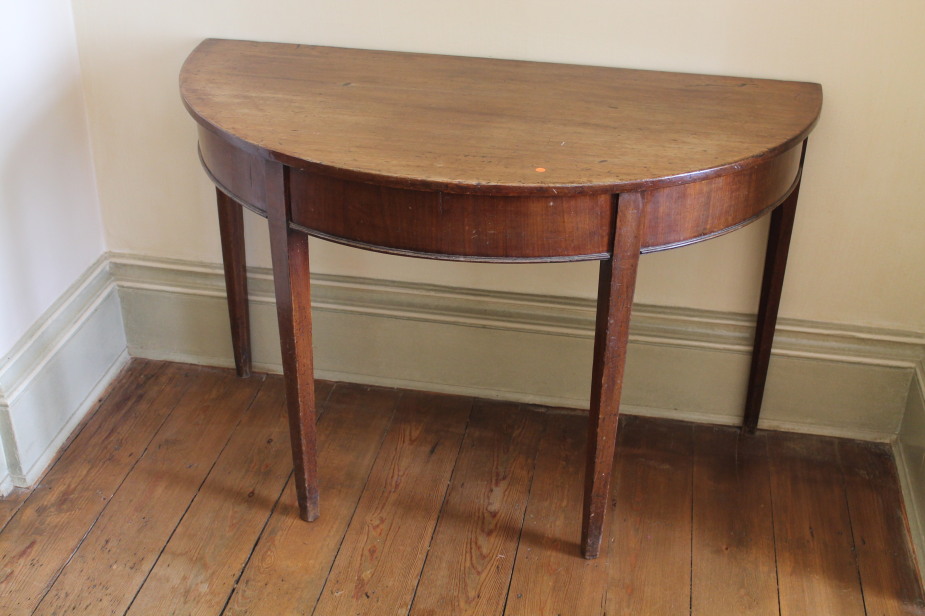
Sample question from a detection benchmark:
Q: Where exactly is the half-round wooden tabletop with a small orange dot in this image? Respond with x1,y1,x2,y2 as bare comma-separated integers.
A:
180,39,822,195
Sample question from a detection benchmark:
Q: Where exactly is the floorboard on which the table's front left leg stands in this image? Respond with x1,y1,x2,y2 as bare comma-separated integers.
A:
224,383,400,616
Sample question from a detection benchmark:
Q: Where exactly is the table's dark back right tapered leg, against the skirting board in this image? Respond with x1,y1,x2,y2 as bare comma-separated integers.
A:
742,164,806,434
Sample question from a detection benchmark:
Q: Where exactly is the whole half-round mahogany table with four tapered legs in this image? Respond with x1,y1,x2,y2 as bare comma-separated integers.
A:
180,39,822,558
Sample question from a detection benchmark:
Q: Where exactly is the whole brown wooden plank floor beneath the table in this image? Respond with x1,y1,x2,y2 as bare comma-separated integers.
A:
0,360,925,616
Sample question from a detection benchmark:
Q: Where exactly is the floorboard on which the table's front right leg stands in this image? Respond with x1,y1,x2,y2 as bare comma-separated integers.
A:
495,414,619,616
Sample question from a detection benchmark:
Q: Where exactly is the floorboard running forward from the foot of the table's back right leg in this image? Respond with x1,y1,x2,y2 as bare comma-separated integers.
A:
691,426,780,616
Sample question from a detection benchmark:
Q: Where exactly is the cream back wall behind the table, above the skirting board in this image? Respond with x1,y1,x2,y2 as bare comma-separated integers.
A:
74,0,925,333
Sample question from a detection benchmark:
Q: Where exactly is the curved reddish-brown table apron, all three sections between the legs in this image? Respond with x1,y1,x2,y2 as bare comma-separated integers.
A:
199,128,802,262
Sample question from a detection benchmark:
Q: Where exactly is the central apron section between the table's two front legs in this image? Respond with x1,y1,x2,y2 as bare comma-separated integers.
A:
292,170,613,261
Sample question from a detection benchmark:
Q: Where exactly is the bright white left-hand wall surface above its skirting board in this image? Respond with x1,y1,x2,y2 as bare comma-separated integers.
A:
0,0,104,356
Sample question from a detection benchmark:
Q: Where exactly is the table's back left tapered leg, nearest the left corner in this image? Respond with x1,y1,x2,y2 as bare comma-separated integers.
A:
215,188,251,377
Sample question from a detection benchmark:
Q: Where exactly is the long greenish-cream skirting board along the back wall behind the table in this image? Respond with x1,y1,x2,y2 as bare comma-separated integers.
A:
111,254,925,441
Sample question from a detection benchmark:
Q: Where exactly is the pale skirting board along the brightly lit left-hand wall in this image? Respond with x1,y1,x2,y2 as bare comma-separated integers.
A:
0,255,128,491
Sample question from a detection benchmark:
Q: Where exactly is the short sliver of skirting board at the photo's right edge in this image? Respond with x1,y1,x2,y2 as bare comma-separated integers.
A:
893,362,925,575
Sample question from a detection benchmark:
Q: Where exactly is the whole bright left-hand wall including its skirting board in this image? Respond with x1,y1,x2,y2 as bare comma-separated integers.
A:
0,0,126,495
